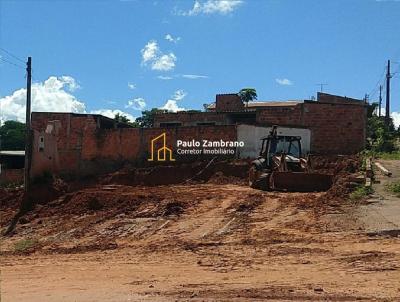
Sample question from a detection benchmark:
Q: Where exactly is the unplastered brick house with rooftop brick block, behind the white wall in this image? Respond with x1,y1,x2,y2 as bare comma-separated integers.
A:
154,93,367,154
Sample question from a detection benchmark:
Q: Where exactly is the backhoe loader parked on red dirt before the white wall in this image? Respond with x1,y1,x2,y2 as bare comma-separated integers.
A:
249,126,333,192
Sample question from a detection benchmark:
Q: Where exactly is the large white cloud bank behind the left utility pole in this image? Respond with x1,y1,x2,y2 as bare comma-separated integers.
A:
0,76,86,122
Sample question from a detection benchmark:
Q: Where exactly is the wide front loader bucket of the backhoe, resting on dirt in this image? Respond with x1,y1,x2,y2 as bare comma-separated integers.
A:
270,171,333,192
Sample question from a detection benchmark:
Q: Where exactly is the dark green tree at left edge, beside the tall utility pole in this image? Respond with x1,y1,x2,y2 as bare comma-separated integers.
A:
0,121,25,150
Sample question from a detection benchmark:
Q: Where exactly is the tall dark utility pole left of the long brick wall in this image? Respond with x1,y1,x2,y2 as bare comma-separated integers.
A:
24,57,32,201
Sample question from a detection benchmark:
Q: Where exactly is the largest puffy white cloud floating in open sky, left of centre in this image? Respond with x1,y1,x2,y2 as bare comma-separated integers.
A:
141,40,177,71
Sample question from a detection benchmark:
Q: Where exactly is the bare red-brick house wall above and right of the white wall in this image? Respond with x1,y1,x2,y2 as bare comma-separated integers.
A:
257,101,367,154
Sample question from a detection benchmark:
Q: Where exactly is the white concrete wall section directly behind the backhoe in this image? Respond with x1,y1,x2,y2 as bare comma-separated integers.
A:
237,125,311,158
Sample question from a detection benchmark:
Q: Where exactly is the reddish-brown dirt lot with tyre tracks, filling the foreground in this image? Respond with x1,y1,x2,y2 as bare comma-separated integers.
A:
1,159,400,302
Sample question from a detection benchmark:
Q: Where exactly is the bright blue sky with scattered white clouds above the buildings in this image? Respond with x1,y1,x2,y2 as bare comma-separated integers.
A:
0,0,400,124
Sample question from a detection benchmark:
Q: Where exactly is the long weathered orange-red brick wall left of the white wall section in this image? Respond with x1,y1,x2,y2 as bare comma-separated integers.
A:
32,114,237,176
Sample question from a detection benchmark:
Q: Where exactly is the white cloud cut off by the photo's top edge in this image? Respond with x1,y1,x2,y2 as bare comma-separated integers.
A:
178,0,243,16
